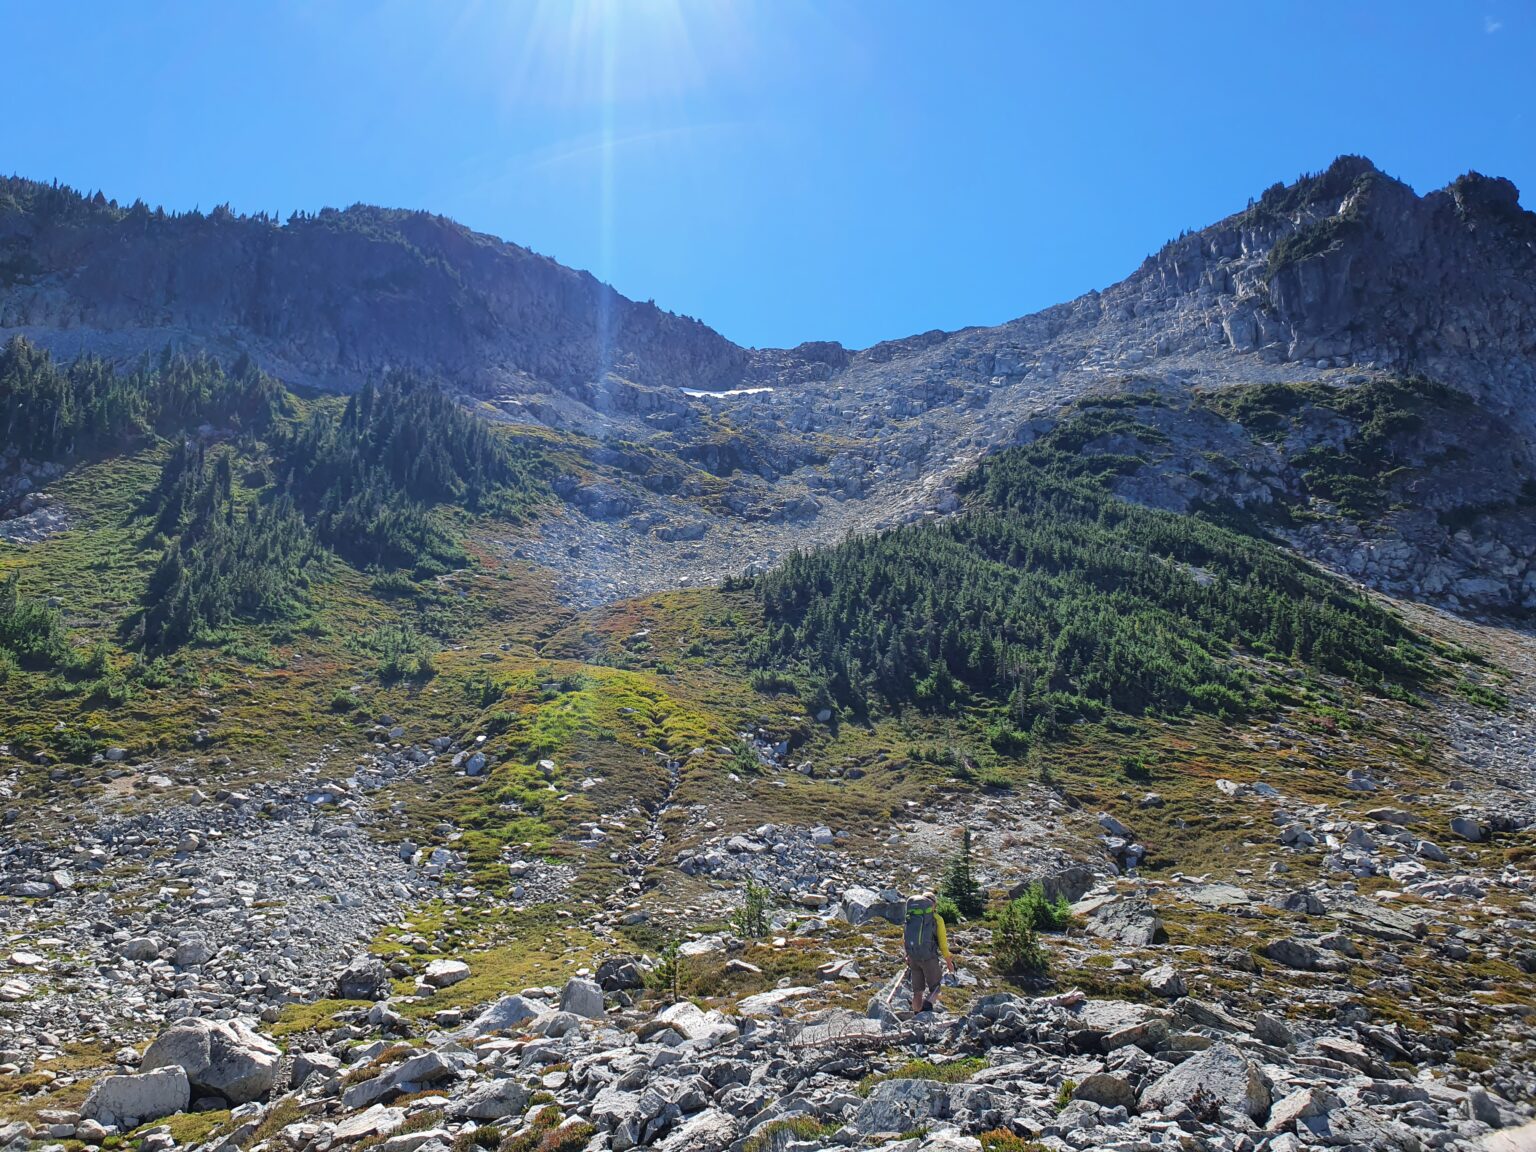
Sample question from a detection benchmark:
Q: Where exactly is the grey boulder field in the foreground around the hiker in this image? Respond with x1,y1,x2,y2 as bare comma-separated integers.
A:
0,605,1536,1152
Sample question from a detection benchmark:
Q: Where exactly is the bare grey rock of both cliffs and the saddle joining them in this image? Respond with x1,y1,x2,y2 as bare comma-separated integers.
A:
0,157,1536,611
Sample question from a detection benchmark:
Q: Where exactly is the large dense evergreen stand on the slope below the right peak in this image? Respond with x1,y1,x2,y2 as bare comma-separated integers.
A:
753,413,1427,731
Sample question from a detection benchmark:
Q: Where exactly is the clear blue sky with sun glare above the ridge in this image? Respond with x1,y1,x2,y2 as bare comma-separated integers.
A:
0,0,1536,346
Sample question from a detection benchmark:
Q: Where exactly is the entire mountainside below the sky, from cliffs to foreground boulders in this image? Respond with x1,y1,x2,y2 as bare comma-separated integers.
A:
0,160,1536,1152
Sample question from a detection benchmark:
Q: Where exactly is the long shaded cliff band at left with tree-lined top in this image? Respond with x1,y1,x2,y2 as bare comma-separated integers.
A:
0,180,746,392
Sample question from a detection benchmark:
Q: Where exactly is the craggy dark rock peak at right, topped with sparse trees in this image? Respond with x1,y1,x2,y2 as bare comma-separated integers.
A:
1106,157,1536,412
